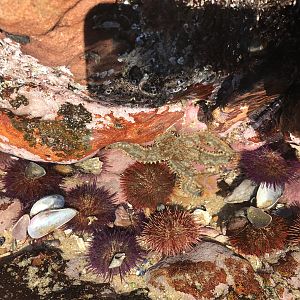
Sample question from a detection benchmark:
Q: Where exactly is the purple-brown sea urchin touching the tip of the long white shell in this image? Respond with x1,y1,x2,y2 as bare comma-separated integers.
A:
65,182,116,232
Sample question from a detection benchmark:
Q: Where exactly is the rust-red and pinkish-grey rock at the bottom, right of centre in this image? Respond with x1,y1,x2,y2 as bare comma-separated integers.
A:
146,242,266,299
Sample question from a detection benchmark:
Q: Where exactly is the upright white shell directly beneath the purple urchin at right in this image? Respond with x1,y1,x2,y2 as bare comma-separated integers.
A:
256,183,283,209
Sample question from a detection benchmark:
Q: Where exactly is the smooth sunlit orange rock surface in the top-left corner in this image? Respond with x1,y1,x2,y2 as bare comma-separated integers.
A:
0,0,114,83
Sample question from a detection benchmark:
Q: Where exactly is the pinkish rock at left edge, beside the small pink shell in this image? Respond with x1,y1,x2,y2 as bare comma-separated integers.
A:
0,197,22,233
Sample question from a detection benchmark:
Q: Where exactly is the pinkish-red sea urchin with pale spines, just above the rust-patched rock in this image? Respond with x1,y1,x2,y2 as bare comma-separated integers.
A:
138,207,201,256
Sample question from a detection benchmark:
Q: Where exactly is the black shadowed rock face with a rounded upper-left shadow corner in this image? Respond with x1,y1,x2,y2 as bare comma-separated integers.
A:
85,0,299,106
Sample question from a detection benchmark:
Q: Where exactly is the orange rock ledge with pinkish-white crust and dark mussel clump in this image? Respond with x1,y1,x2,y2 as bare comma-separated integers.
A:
0,39,184,163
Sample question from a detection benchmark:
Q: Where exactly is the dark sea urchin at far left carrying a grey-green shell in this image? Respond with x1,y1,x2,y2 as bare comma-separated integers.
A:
1,159,62,208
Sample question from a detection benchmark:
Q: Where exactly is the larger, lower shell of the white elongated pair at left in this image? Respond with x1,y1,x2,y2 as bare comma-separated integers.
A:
27,208,77,239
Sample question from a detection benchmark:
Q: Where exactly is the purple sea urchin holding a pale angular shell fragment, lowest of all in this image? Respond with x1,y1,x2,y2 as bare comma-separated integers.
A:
88,227,145,280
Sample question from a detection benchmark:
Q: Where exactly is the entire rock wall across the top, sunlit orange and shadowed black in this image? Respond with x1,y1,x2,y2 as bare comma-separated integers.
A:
0,0,300,106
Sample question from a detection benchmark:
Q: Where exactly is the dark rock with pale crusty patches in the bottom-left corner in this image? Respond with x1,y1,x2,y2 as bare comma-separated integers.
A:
0,248,150,300
